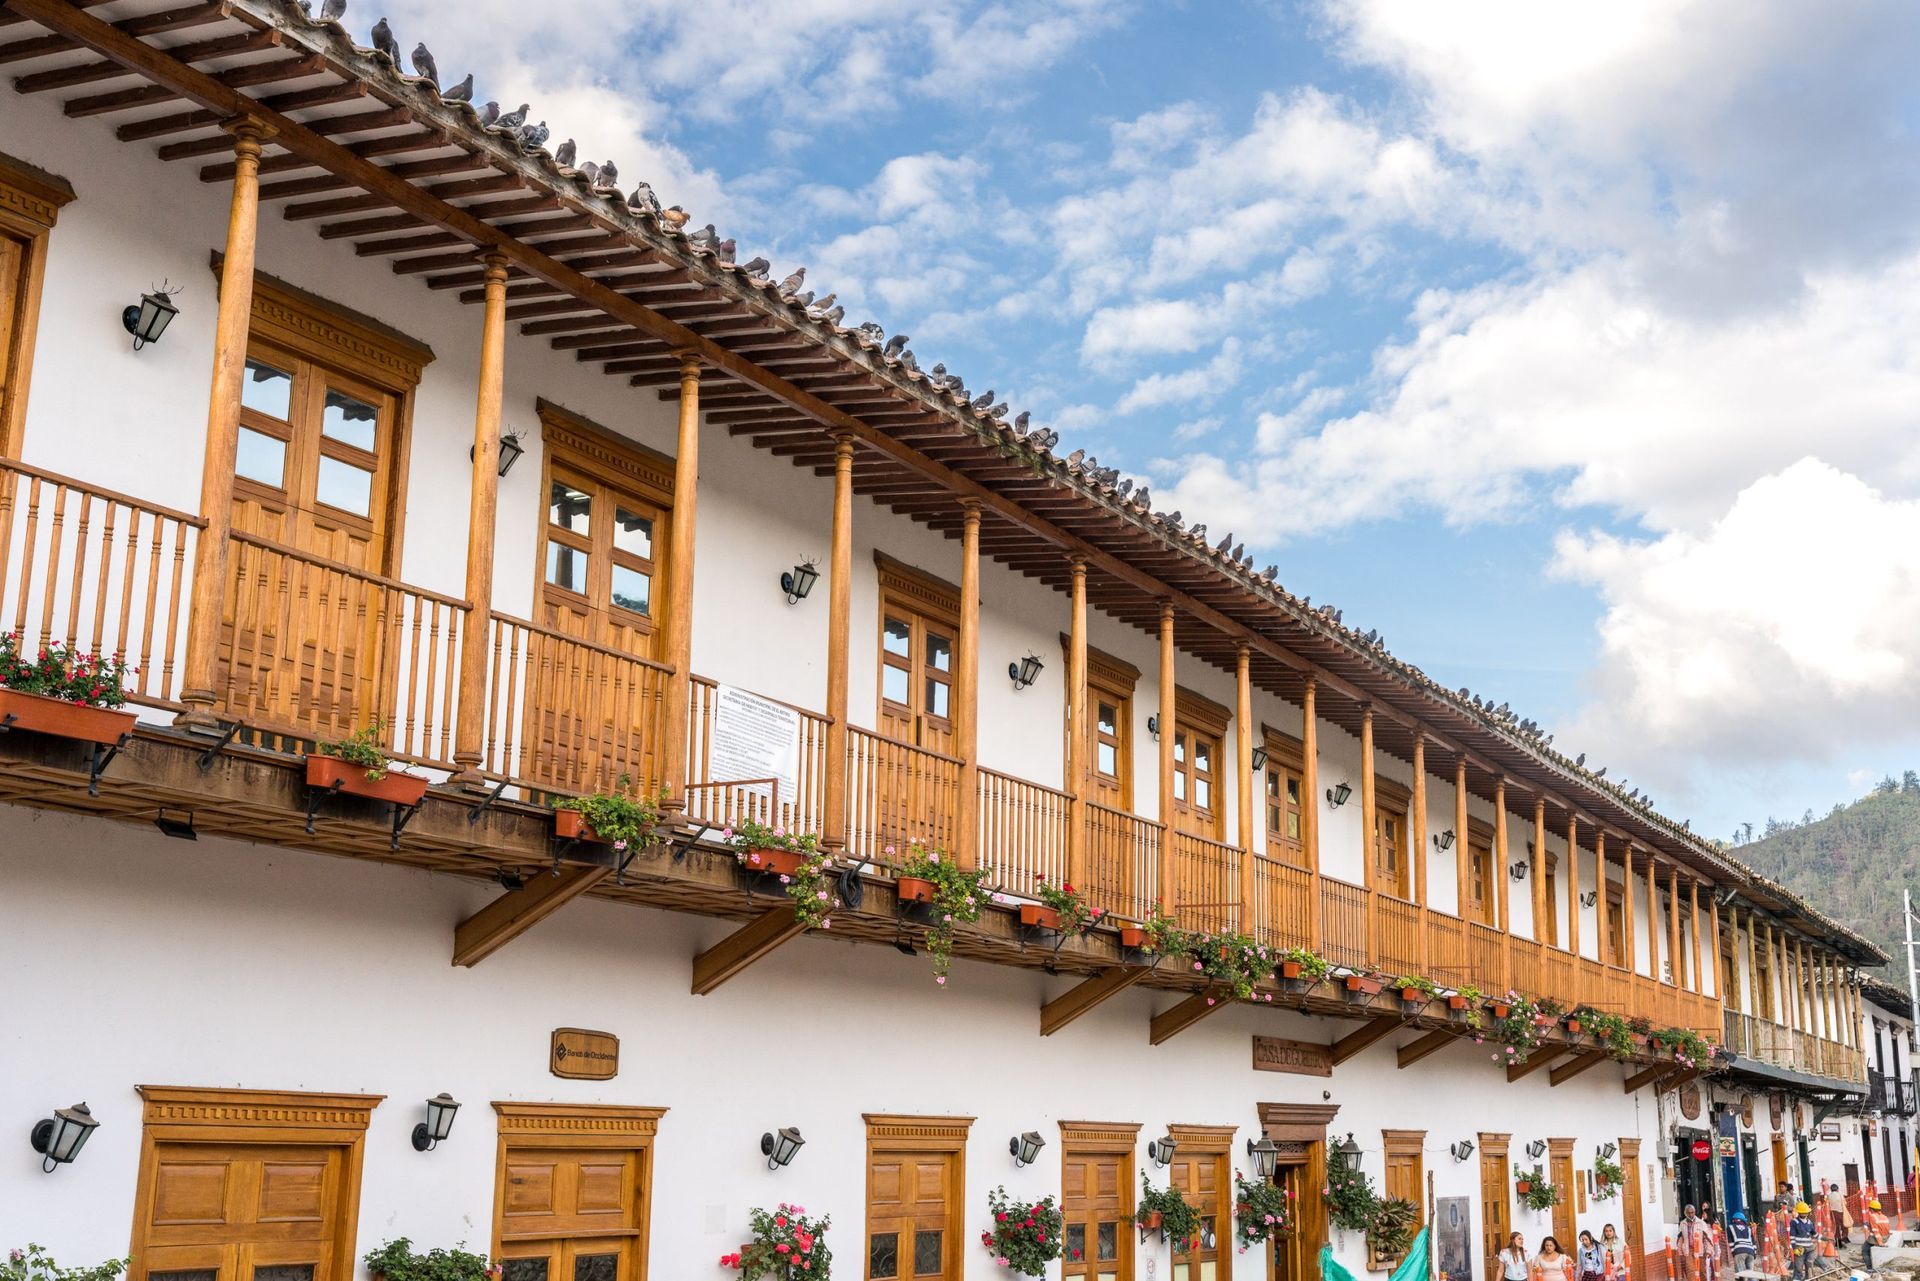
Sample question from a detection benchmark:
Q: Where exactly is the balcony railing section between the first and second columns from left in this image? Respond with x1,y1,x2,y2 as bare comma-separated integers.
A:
215,532,467,766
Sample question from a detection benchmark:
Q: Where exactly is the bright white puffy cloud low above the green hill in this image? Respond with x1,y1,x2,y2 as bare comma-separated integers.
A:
1555,457,1920,786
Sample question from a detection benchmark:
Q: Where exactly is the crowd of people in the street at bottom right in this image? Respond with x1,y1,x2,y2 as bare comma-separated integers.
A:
1500,1183,1893,1281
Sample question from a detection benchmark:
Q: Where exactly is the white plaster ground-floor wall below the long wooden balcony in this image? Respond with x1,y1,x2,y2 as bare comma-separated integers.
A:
0,809,1661,1277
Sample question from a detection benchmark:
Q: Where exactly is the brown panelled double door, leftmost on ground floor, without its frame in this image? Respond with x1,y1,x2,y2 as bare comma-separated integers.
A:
132,1143,353,1281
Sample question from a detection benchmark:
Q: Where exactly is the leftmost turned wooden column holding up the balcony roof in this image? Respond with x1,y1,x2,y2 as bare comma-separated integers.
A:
175,117,273,730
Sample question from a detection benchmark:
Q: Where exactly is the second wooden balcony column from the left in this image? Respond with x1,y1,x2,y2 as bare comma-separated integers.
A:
449,252,510,786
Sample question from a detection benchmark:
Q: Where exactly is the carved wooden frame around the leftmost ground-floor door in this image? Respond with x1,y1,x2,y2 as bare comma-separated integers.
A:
129,1085,386,1279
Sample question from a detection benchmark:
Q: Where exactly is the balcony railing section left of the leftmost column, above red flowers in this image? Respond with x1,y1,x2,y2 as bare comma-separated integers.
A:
0,459,205,709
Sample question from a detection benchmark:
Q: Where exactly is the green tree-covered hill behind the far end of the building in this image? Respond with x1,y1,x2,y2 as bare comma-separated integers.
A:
1732,783,1920,971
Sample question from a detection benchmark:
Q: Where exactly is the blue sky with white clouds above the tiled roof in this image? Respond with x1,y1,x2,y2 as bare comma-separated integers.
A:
378,0,1920,834
